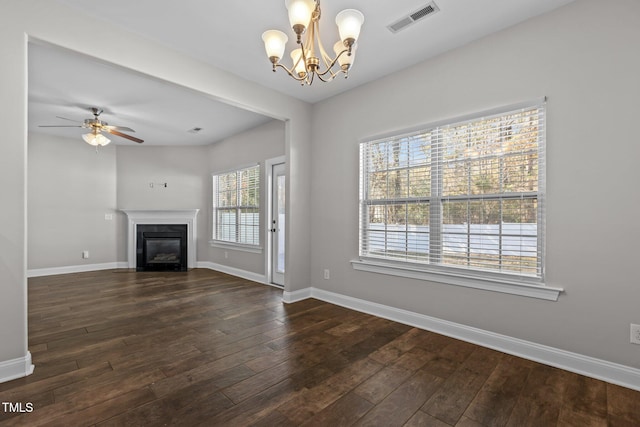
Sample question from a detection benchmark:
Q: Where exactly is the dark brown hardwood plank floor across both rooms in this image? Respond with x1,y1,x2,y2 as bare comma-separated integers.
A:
0,270,640,427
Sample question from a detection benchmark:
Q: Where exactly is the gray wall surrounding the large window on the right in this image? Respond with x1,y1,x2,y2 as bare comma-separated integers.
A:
311,0,640,368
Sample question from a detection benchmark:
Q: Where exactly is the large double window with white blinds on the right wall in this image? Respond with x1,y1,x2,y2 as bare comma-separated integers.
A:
360,102,545,281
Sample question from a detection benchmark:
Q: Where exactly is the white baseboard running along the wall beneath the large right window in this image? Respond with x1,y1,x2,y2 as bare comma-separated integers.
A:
283,288,640,391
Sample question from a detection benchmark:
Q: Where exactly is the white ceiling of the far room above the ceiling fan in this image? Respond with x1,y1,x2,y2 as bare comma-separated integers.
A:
29,44,271,146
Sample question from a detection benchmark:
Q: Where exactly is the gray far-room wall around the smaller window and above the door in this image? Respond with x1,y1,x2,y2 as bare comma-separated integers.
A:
208,120,285,274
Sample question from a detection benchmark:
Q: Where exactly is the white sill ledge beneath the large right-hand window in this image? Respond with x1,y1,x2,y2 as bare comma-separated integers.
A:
351,259,564,301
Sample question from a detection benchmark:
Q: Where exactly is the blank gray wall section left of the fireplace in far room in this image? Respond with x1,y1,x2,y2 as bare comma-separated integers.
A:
27,134,117,270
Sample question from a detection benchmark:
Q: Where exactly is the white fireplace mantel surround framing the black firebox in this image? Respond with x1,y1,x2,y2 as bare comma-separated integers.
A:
122,209,200,268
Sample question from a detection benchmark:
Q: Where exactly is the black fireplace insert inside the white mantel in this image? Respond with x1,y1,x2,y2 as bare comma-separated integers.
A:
136,224,187,271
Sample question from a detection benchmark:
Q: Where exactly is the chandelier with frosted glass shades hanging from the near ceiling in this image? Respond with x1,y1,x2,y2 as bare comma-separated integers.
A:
262,0,364,85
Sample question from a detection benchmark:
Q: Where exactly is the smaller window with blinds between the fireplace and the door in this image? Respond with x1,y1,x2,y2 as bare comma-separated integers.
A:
213,165,260,246
